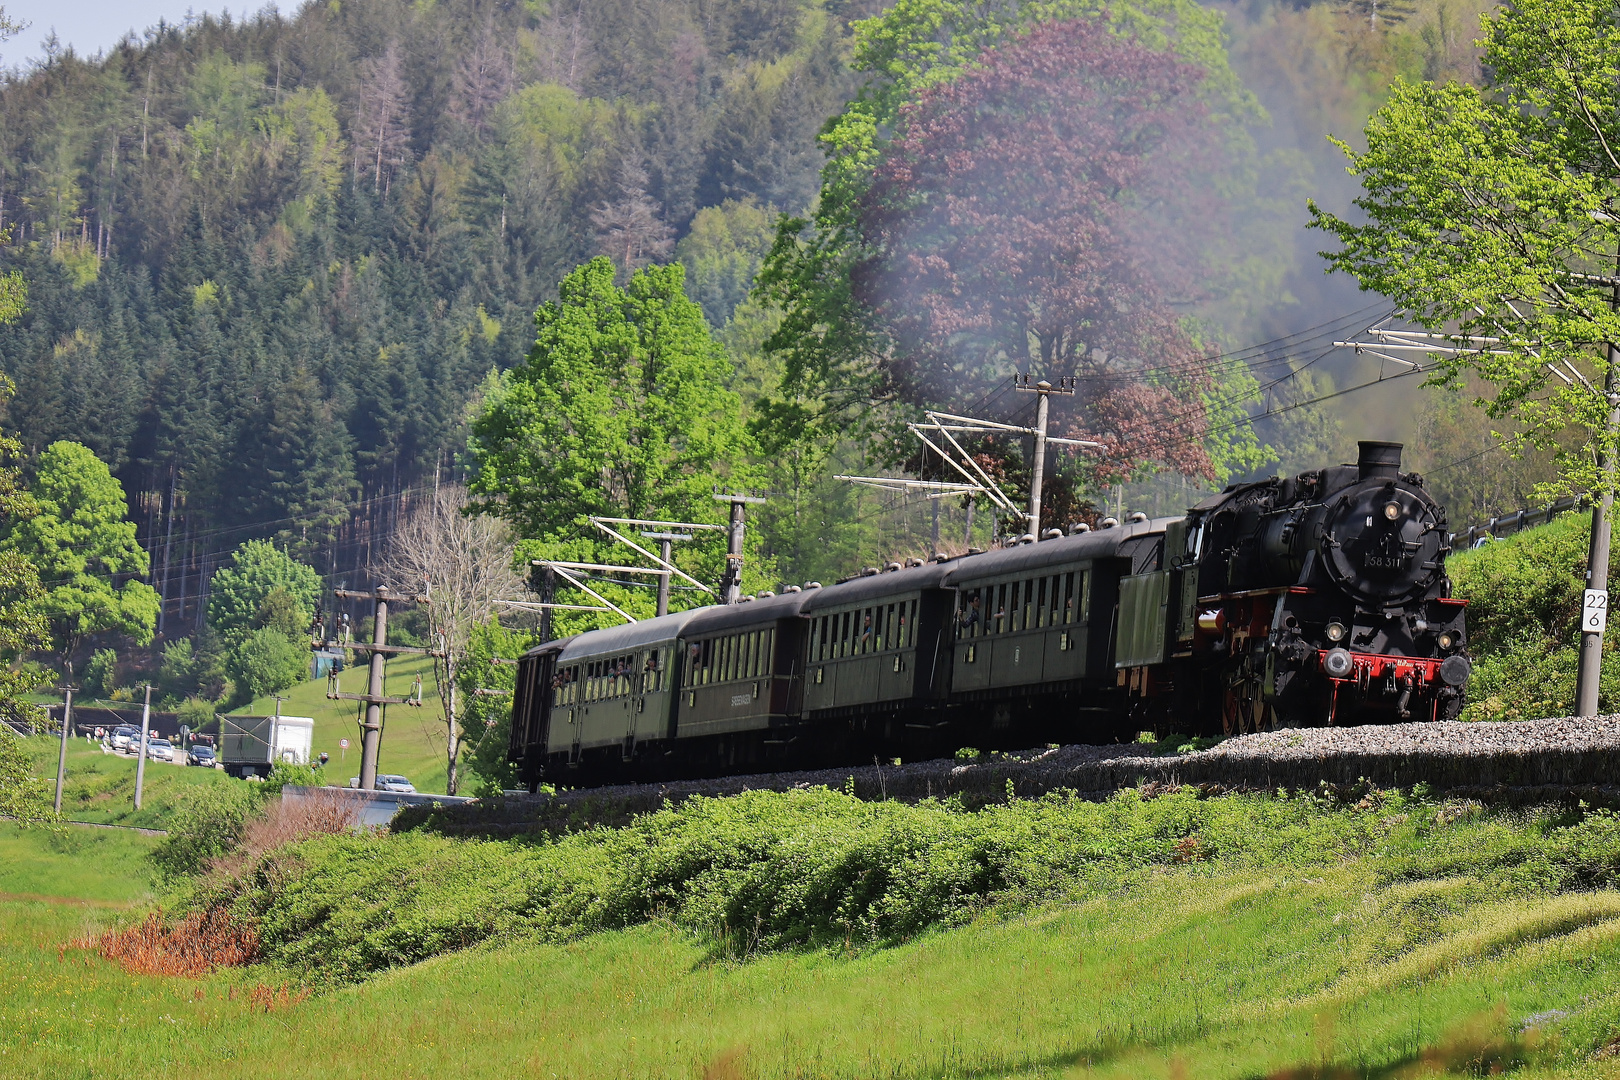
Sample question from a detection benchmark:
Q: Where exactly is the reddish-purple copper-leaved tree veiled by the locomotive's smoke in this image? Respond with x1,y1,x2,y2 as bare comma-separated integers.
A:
851,18,1223,476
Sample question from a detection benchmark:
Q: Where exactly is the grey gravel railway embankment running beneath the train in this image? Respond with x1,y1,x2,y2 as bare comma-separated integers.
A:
410,716,1620,832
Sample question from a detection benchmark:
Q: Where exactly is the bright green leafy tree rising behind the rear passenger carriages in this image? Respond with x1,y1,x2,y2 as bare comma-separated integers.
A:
468,257,770,625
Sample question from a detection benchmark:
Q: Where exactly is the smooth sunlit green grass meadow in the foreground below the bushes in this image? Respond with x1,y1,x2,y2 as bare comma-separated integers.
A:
0,790,1620,1080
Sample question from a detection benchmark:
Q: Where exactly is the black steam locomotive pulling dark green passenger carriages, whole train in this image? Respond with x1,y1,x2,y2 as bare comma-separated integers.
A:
509,442,1471,789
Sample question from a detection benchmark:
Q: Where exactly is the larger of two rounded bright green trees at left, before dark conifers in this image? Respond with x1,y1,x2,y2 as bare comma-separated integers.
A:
0,442,157,657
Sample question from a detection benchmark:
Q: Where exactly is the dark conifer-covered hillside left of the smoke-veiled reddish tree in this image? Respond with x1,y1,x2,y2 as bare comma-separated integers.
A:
0,0,865,615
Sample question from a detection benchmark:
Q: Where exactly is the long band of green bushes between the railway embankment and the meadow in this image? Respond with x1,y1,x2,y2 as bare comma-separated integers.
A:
170,789,1620,981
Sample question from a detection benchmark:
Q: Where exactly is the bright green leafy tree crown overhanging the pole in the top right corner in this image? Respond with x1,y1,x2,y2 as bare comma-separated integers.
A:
1312,0,1620,489
